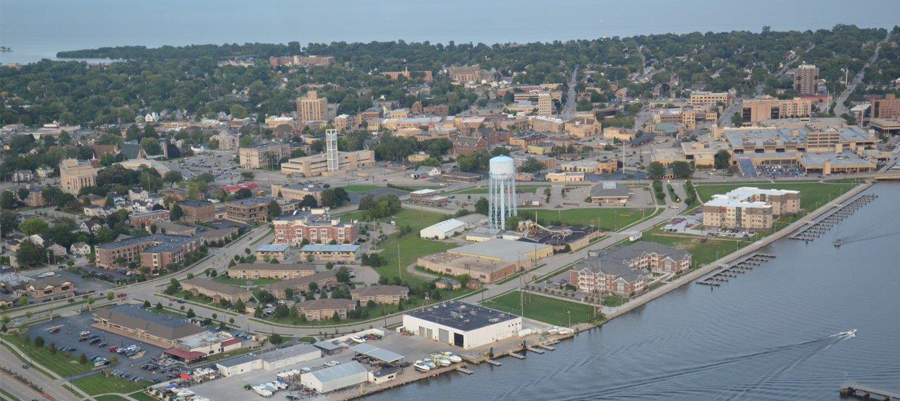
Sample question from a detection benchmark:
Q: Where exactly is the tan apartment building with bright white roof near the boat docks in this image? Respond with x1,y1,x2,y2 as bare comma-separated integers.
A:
703,187,800,231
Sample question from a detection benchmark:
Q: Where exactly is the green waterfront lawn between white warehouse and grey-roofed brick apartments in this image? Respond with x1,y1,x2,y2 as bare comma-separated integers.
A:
482,291,602,326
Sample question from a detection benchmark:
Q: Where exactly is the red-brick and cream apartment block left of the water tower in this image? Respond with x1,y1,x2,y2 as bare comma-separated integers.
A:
272,209,359,246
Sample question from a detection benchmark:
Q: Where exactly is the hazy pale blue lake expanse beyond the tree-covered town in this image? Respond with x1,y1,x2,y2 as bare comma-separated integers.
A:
0,0,900,63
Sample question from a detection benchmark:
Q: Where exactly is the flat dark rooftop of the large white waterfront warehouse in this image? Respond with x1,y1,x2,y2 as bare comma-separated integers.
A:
408,301,521,331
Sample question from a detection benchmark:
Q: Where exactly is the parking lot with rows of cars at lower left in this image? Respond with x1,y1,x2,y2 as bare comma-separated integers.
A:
28,312,166,380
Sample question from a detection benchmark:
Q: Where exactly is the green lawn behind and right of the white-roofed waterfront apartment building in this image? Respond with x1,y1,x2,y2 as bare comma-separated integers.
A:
694,182,858,212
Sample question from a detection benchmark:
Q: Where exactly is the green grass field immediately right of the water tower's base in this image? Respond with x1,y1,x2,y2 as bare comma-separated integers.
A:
519,208,652,231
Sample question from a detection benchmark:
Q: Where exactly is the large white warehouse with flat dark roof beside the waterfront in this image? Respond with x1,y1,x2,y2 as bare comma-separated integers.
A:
403,301,522,349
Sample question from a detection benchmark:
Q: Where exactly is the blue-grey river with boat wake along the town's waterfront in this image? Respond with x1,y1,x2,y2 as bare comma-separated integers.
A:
367,183,900,401
